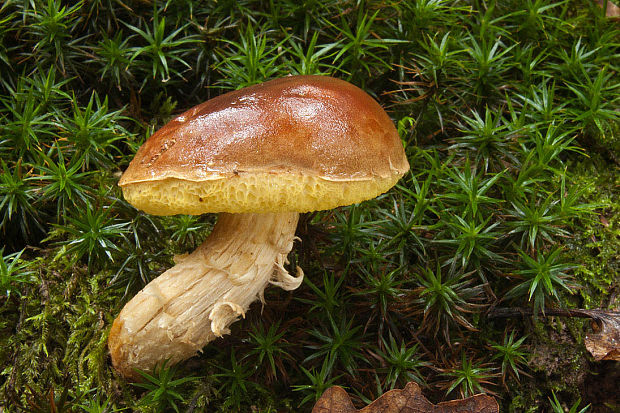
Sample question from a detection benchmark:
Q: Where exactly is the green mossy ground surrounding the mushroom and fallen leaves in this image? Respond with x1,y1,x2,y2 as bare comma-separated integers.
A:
0,0,620,412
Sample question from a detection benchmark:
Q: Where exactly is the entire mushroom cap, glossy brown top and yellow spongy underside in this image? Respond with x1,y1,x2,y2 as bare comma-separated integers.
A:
119,76,409,215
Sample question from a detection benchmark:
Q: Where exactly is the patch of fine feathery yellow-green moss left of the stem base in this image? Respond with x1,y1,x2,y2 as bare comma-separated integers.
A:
0,254,119,405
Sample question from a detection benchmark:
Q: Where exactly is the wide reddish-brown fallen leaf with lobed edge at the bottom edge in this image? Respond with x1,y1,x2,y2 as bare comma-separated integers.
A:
312,382,499,413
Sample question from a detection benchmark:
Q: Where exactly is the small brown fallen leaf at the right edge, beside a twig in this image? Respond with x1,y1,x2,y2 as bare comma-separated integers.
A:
584,312,620,361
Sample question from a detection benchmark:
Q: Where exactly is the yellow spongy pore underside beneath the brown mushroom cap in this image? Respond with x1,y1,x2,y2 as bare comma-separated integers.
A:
122,173,401,215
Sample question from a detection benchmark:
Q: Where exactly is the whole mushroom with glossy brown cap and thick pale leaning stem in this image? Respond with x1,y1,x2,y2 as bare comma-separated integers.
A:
108,76,409,378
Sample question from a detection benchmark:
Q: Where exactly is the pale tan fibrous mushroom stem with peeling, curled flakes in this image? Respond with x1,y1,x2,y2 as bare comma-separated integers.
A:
108,212,303,377
